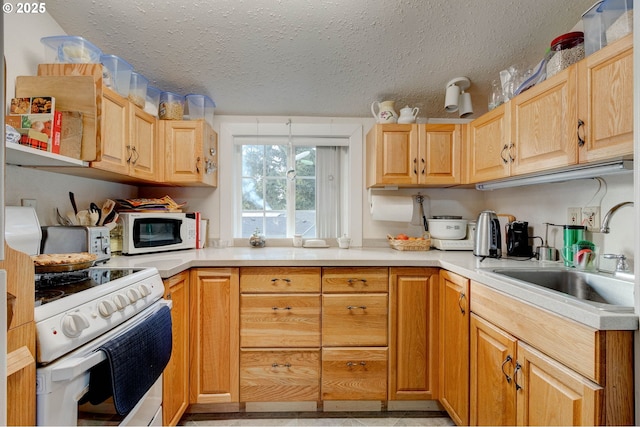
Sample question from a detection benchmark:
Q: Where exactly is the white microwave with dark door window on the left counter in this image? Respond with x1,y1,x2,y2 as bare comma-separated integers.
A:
119,212,197,255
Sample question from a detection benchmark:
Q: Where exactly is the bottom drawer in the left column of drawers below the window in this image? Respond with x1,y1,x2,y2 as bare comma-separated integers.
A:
240,350,320,402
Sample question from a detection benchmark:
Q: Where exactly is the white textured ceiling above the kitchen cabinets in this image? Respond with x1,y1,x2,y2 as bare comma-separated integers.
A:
47,0,594,118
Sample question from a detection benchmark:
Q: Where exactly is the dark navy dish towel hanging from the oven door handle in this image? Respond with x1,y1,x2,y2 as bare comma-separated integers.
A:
87,306,172,415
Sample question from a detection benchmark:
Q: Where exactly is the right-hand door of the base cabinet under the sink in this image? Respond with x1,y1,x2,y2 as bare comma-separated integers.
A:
514,342,604,426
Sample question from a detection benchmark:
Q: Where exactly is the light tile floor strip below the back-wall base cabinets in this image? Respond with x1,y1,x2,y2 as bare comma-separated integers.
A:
179,411,455,427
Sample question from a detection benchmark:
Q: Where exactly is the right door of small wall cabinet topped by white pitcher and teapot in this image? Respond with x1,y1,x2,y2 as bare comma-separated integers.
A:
418,124,461,186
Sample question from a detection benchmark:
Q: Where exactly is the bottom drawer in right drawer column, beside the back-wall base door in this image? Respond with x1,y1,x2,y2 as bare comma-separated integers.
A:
322,348,387,400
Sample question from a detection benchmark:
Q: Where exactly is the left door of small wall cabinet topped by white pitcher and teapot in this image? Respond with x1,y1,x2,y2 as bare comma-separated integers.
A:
366,124,418,187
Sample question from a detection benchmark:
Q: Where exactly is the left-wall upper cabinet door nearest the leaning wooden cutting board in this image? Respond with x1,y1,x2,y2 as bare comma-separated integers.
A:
91,88,132,175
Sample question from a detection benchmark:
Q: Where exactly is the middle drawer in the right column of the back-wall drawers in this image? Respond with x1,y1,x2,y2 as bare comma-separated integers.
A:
322,294,389,346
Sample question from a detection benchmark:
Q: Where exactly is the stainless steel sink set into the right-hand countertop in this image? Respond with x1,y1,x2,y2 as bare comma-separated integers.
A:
490,268,634,311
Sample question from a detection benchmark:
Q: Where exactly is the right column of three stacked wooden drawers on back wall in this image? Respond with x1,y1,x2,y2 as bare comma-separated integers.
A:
321,267,389,400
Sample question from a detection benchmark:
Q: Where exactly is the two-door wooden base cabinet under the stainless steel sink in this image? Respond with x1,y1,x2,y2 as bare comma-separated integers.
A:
470,281,634,425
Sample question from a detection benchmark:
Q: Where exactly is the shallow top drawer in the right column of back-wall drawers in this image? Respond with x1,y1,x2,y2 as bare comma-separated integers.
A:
322,267,389,293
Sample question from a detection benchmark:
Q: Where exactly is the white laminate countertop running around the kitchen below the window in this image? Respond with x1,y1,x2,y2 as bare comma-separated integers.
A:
106,246,638,330
